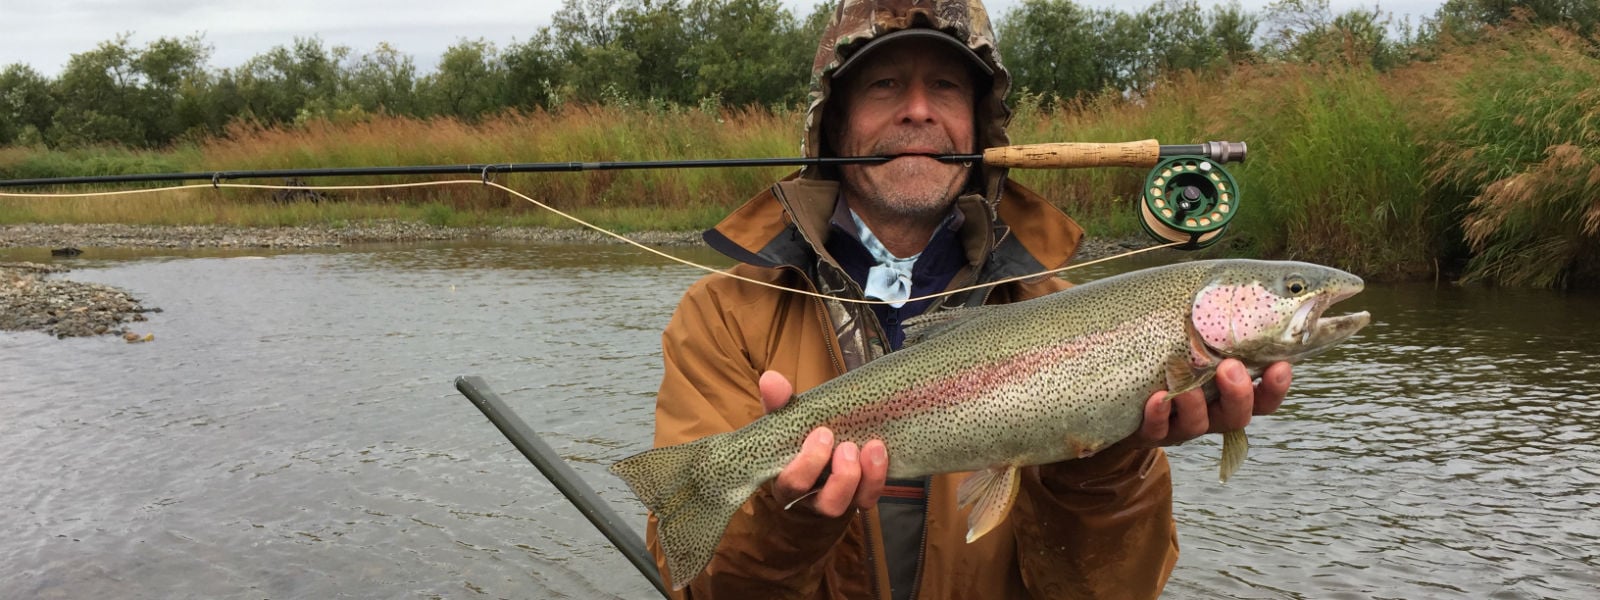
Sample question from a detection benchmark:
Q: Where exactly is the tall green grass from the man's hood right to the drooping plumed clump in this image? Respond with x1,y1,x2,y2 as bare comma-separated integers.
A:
1013,66,1432,278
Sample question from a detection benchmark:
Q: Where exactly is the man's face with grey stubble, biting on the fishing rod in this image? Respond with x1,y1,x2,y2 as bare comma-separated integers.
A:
834,40,976,219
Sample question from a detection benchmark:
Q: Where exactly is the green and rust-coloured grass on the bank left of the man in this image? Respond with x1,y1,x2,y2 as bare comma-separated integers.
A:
0,106,800,230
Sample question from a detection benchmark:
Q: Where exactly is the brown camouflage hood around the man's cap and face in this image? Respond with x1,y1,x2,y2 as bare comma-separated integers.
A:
802,0,1011,202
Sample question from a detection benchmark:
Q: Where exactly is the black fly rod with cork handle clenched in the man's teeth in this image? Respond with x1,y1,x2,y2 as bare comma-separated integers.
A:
0,139,1245,187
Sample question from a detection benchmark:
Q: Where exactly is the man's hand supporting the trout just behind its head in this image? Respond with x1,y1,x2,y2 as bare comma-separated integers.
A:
1128,358,1291,448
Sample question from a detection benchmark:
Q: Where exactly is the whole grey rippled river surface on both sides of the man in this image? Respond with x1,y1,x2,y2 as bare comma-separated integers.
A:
0,243,1600,598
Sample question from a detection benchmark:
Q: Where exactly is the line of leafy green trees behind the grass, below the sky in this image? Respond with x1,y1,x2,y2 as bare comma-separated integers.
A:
0,0,1600,149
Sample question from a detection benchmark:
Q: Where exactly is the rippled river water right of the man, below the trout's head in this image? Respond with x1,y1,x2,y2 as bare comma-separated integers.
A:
1171,278,1600,598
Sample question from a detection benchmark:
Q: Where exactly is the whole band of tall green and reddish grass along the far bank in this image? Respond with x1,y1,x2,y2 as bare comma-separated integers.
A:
0,26,1600,286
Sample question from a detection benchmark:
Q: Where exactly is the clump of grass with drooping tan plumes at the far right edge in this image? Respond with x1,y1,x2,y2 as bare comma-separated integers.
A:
1421,27,1600,288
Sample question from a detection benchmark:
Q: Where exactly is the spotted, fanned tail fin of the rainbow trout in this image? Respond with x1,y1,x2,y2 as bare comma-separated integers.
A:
611,432,762,589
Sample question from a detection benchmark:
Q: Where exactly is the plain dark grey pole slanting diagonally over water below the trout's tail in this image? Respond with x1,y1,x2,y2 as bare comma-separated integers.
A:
456,376,670,598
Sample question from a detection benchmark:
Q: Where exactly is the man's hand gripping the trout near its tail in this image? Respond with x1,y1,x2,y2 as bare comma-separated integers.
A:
760,371,889,517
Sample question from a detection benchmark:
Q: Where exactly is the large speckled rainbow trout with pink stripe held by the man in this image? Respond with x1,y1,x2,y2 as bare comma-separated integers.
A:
611,261,1370,587
